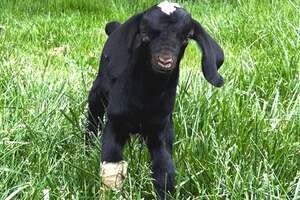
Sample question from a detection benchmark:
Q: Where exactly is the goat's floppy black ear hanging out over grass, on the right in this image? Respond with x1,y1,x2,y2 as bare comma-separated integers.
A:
191,20,224,87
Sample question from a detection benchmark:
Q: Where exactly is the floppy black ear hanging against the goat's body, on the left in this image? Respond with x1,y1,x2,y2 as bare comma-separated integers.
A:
102,13,143,78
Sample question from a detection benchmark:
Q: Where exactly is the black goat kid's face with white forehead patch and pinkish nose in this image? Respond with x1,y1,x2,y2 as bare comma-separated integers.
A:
139,4,193,73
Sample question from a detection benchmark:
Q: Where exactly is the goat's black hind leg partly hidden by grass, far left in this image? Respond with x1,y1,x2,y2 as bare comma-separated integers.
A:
85,79,107,144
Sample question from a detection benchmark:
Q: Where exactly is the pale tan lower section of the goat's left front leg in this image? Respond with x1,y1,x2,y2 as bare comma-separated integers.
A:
100,161,128,189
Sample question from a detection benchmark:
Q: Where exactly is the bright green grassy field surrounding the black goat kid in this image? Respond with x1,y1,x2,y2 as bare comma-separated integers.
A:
0,0,300,200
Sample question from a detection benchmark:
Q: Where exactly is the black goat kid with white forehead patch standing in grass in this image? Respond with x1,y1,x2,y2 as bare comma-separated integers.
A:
86,2,224,198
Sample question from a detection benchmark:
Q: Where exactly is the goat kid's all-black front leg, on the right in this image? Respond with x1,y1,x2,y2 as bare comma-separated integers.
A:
143,122,175,199
